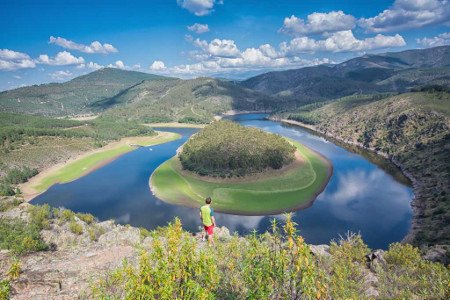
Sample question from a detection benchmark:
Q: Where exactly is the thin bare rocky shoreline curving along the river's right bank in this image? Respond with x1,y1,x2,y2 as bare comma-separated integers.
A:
276,118,424,243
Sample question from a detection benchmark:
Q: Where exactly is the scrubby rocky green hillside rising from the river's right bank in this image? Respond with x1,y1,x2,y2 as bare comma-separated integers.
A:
289,92,450,251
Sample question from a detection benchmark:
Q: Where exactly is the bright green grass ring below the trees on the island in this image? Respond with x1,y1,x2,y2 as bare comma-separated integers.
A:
150,141,332,215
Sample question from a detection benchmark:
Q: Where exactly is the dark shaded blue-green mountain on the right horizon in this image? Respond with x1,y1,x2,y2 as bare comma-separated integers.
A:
241,46,450,104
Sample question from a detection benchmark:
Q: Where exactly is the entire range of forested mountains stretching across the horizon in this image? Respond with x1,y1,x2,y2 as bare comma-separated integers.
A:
0,46,450,122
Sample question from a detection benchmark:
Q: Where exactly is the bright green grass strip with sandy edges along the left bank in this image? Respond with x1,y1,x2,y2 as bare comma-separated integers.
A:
22,132,181,194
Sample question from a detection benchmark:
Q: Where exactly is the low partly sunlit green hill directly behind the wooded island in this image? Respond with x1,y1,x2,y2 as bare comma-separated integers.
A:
101,77,284,123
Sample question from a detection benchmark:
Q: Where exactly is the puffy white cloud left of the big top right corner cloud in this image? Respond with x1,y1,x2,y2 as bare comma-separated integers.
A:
281,10,356,36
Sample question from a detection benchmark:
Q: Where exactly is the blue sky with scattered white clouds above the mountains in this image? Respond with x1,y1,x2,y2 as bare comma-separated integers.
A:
0,0,450,90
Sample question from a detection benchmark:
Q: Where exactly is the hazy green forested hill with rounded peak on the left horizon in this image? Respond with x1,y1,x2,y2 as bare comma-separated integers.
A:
0,68,171,116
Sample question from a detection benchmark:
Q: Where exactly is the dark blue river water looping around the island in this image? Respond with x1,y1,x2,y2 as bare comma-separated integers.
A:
32,114,413,248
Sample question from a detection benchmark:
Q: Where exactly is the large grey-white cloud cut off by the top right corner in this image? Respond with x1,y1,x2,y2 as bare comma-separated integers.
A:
359,0,450,32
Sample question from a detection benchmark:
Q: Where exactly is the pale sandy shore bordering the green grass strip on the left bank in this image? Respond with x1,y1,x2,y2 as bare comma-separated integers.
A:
19,131,180,202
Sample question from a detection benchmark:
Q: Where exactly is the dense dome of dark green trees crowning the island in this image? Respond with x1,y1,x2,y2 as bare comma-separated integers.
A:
179,121,296,177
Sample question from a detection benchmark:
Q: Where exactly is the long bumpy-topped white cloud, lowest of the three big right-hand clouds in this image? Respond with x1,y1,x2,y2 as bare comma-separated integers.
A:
280,30,406,55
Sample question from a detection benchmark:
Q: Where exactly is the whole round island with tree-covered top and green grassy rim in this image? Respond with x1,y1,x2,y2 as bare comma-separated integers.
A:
150,121,332,215
